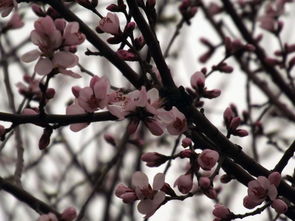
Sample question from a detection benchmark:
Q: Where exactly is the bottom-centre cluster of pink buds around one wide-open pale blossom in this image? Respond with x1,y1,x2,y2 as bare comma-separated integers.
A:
115,142,219,218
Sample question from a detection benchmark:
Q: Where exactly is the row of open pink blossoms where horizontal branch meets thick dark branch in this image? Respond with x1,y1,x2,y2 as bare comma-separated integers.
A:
66,76,187,136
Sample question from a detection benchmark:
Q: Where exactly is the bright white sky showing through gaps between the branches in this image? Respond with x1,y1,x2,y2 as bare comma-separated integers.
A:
0,0,295,221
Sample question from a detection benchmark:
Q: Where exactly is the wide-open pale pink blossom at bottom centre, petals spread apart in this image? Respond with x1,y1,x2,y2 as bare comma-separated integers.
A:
132,172,165,218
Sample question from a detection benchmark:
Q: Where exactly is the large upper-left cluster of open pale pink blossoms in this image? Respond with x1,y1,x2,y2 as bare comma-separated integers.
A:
22,16,85,78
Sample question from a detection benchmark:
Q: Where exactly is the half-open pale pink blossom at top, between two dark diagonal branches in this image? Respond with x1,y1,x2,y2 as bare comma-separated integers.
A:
99,12,121,35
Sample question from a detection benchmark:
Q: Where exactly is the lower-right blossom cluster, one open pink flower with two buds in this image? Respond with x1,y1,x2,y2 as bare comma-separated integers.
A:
244,172,288,213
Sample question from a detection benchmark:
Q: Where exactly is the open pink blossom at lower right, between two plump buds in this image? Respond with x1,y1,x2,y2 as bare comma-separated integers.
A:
248,176,278,205
